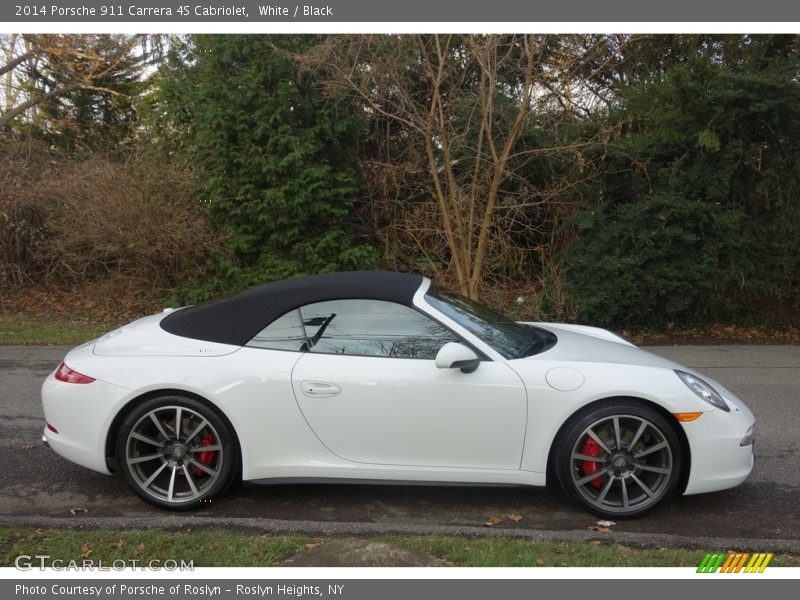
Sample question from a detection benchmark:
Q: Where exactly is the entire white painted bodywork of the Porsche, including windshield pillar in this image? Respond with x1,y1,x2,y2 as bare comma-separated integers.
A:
42,280,754,508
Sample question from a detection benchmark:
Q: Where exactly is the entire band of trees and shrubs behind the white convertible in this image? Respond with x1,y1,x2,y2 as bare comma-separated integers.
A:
0,35,800,329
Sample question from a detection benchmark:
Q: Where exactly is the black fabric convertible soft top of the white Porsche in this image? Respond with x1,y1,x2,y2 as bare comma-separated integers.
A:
160,271,422,346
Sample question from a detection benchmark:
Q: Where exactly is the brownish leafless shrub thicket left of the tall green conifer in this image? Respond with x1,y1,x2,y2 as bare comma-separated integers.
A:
0,145,215,291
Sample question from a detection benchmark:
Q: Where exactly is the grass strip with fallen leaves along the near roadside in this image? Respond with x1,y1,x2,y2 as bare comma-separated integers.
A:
0,527,800,568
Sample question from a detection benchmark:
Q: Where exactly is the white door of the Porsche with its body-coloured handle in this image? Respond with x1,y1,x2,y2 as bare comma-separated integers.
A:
292,353,528,469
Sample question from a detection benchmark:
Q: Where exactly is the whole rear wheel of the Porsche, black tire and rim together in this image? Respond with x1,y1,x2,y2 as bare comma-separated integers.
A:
116,395,239,510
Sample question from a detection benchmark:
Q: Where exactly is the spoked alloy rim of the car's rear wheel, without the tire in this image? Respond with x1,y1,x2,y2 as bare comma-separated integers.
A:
125,406,224,504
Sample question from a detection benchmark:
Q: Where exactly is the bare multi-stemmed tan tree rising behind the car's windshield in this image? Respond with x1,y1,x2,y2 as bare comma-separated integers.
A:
310,35,613,298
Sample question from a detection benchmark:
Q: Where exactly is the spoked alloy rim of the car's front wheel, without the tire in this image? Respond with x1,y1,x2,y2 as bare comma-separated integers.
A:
570,414,673,515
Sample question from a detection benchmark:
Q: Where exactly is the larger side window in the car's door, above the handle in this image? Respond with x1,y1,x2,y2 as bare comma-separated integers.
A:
300,300,457,360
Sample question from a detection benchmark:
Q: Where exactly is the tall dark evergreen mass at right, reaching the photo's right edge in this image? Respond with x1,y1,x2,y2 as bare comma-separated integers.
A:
565,45,800,327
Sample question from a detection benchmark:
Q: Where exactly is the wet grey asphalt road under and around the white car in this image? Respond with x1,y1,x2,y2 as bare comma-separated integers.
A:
0,346,800,553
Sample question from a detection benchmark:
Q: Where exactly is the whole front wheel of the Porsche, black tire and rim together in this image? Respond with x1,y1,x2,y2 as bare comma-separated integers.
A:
554,400,683,518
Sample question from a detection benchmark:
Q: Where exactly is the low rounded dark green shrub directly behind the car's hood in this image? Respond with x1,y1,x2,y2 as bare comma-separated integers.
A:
566,196,743,327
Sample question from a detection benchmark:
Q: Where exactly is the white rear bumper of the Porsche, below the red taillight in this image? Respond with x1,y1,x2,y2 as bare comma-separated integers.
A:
42,373,131,474
